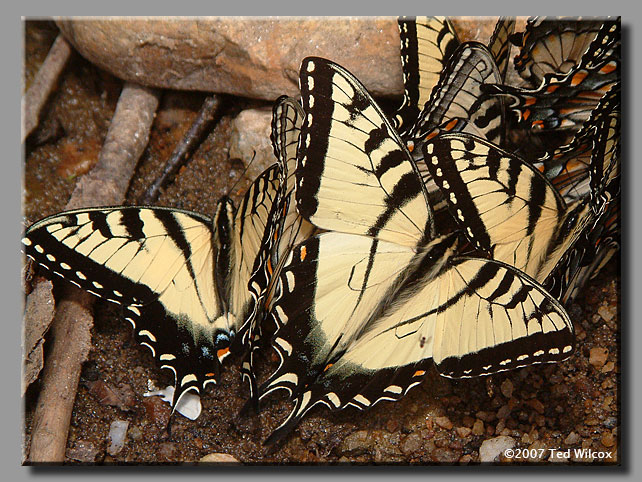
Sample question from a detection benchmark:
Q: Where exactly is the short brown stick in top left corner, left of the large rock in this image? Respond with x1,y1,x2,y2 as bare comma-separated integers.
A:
21,34,72,143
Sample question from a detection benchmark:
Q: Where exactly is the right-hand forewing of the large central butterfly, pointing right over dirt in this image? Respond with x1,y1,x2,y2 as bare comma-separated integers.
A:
433,257,575,378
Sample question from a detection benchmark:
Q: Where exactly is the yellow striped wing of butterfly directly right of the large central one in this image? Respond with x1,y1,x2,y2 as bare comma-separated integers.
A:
424,133,592,282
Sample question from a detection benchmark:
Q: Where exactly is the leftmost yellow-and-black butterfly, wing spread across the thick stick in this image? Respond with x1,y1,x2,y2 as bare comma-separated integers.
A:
22,165,279,407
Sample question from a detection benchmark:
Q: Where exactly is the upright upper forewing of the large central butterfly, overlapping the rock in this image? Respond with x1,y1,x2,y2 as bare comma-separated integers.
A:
296,57,434,246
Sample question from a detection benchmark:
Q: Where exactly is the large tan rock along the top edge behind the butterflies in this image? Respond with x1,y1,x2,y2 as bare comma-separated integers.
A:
57,17,504,100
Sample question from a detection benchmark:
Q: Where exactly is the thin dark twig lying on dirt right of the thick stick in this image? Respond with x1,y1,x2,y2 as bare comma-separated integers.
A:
139,95,221,204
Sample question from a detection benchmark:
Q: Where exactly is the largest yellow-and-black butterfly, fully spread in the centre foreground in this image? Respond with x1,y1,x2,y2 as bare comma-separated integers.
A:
254,57,574,444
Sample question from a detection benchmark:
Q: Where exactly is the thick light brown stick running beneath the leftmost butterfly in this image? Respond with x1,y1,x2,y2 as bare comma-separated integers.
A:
29,84,159,463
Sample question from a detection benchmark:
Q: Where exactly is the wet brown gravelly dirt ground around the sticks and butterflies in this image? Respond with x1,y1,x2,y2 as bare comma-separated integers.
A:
23,22,620,464
